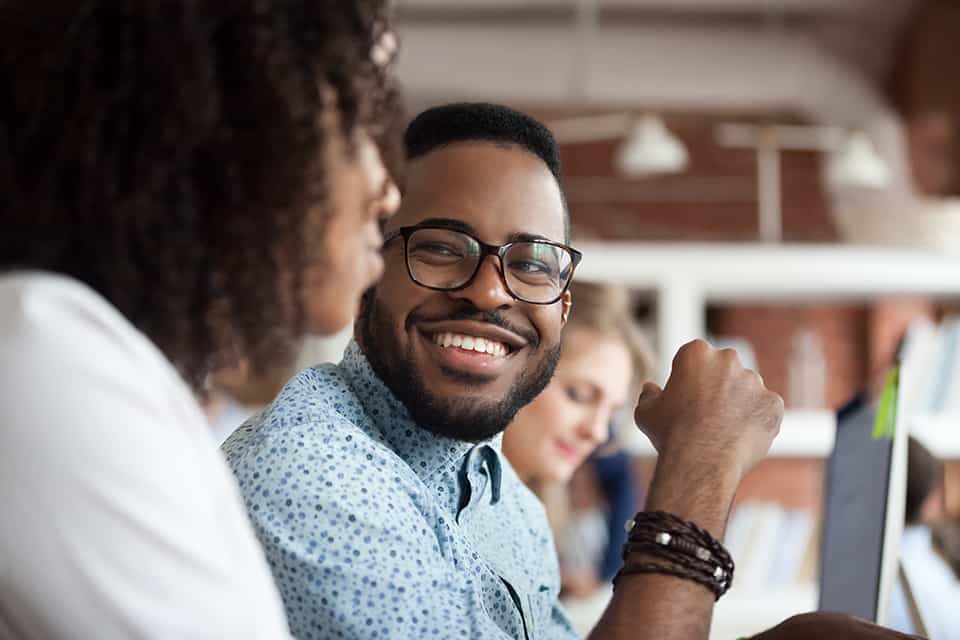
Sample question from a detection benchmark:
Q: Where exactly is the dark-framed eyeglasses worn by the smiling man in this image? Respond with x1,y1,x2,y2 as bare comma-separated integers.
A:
383,225,583,304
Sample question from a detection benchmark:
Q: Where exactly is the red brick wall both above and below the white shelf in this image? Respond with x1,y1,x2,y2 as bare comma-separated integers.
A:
534,110,944,416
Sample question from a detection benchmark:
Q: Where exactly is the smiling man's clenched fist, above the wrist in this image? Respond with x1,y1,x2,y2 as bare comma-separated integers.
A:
634,340,783,483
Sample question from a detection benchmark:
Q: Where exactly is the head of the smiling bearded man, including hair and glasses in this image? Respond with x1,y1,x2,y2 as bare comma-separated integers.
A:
358,122,580,442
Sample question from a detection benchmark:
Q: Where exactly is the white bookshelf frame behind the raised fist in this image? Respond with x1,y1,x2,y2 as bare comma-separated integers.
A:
577,242,960,458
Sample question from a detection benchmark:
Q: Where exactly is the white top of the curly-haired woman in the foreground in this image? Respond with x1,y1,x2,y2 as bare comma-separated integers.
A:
0,272,289,640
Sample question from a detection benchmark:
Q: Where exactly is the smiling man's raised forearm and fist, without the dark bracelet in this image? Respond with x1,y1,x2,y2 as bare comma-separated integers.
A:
590,340,784,640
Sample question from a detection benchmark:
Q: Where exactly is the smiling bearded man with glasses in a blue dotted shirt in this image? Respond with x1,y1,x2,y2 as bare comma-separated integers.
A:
224,104,916,640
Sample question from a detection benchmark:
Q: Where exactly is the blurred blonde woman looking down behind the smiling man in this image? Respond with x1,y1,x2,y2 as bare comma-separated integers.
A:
503,282,653,597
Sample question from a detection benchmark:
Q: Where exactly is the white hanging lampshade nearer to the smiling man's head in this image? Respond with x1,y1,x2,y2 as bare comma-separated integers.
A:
614,114,690,176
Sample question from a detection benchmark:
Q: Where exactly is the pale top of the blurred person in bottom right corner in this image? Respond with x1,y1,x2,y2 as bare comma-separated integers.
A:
888,525,960,640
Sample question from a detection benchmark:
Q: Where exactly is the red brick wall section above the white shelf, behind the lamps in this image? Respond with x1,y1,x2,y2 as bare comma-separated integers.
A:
562,115,837,242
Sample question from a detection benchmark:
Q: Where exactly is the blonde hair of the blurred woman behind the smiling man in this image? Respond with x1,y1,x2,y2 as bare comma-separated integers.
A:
563,281,656,387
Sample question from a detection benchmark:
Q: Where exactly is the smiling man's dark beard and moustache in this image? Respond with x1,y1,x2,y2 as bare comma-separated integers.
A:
358,289,560,442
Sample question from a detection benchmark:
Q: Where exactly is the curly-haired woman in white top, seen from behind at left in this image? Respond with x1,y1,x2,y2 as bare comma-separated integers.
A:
0,0,397,639
